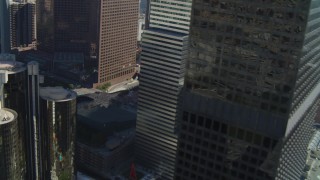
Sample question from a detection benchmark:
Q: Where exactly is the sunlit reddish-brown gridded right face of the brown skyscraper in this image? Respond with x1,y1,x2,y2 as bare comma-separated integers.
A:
97,0,139,84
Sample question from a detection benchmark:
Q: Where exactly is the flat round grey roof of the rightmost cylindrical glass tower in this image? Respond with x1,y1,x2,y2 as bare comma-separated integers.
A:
40,87,77,102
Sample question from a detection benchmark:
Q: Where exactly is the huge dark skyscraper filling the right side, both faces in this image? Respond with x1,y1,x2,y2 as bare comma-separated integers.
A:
175,0,320,180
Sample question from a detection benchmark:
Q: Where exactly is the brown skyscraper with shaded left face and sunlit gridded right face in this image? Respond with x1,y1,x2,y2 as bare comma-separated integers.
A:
52,0,139,86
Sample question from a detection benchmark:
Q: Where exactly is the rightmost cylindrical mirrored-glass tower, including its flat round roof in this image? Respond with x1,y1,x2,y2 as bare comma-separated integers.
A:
39,87,77,179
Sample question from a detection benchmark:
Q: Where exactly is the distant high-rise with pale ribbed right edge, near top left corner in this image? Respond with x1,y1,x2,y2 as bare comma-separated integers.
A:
10,2,36,49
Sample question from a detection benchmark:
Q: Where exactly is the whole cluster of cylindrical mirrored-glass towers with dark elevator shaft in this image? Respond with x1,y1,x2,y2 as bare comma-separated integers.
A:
0,57,76,180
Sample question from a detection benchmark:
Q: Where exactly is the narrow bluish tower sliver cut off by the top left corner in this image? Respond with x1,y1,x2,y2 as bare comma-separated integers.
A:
0,0,10,53
